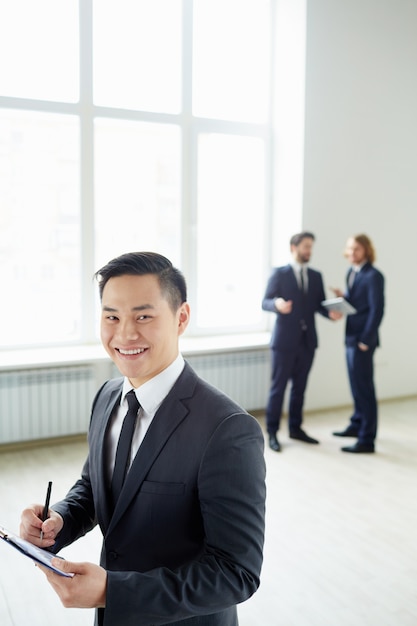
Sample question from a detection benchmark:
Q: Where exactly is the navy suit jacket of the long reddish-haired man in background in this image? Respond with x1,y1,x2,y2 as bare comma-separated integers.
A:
345,263,384,348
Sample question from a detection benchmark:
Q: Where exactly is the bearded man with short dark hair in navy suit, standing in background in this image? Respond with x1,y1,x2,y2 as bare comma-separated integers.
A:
262,232,341,452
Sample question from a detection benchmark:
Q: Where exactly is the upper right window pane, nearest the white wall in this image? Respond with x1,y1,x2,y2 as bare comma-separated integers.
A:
193,0,270,123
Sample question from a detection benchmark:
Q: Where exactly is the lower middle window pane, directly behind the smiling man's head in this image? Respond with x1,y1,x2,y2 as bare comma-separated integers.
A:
95,119,181,267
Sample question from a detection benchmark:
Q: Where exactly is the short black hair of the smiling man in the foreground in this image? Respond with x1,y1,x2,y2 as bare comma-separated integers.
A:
94,252,187,312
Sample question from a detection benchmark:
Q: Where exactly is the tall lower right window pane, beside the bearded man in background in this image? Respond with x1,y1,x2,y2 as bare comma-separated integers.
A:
197,134,265,331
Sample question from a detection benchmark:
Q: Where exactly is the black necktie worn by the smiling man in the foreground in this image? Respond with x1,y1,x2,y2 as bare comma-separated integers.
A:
111,389,140,505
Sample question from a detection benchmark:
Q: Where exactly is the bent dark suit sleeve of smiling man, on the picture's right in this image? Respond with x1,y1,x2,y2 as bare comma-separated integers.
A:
104,413,265,626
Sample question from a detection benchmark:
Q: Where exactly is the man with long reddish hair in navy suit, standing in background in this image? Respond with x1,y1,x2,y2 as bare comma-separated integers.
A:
333,235,384,453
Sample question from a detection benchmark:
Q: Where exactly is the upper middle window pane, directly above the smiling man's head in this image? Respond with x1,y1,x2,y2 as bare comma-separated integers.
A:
93,0,181,113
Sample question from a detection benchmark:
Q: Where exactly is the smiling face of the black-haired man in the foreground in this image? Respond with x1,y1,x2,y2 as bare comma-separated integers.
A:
101,274,190,387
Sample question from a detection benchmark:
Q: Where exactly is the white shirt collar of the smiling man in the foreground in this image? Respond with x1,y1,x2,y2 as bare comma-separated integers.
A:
121,354,185,415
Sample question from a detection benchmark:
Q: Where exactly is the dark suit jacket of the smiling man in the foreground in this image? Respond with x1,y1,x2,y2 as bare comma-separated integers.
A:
53,363,265,626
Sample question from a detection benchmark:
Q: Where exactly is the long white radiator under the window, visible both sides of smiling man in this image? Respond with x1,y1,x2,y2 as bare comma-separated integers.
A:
0,349,270,444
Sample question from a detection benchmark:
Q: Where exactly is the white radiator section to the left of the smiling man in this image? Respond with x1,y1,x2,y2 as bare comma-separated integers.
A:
0,365,96,443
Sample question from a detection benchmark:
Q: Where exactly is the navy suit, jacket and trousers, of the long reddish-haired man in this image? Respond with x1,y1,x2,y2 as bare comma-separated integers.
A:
345,263,384,445
